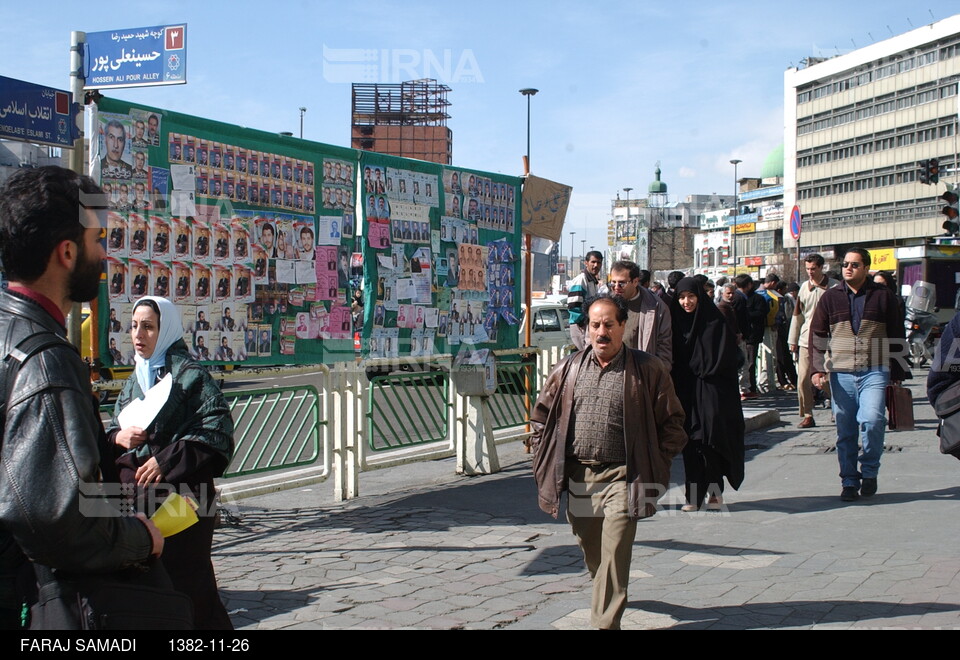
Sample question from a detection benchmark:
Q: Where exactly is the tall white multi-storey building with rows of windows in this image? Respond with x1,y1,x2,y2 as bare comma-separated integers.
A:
783,15,960,306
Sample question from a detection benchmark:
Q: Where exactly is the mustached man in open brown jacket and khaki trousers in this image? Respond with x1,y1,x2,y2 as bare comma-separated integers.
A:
531,295,687,629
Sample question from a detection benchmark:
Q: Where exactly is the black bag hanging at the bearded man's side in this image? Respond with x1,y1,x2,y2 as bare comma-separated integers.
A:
27,559,193,630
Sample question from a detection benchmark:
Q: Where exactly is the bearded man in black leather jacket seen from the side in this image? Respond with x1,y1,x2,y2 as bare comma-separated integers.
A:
0,167,163,628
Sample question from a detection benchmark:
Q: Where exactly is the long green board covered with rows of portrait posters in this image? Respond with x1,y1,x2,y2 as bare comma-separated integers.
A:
90,98,520,367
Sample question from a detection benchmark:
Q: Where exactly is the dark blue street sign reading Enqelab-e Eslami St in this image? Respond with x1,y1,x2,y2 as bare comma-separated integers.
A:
0,76,81,148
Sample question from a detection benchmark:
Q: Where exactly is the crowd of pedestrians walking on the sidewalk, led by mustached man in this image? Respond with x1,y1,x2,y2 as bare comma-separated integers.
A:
548,253,908,628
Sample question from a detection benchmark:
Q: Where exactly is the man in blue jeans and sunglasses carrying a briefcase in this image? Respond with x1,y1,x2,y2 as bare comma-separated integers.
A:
809,247,906,502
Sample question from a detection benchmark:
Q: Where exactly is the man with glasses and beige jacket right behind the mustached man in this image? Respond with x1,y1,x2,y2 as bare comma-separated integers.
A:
609,261,673,369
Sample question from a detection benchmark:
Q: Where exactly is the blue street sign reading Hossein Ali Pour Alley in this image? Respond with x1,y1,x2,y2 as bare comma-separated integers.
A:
84,24,187,89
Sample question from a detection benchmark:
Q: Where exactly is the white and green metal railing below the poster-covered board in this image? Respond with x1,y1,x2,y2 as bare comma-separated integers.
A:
103,346,571,501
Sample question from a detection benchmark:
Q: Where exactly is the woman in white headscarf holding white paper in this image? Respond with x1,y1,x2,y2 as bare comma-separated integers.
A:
107,296,233,629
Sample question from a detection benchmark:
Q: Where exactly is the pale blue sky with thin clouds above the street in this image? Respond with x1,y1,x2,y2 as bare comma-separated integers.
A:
0,0,949,255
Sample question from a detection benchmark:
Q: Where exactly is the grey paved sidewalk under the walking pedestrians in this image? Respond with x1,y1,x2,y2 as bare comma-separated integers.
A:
214,370,960,629
